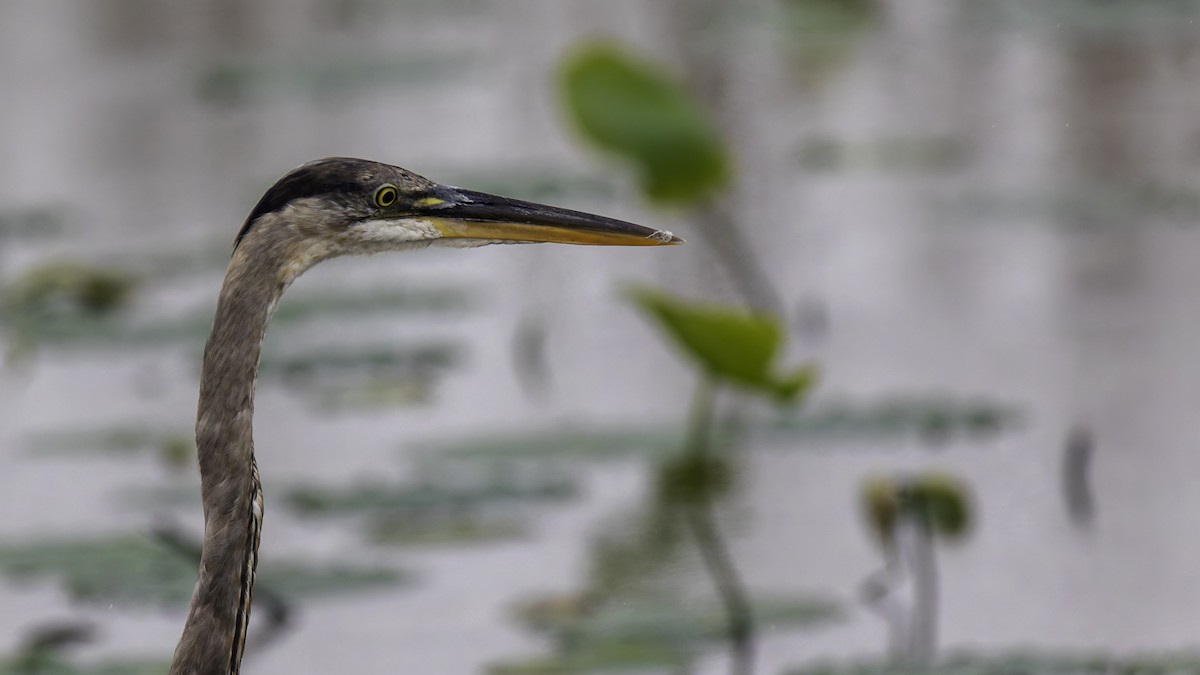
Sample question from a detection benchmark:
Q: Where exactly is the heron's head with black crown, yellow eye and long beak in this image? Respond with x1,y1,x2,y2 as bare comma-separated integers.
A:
235,157,683,259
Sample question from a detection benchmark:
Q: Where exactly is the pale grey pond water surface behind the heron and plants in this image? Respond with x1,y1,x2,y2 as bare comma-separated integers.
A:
0,0,1200,673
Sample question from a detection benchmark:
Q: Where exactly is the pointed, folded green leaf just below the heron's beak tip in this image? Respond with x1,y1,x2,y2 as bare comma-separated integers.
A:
629,283,816,401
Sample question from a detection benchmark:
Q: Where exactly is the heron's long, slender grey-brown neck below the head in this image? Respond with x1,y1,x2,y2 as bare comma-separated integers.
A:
170,227,298,675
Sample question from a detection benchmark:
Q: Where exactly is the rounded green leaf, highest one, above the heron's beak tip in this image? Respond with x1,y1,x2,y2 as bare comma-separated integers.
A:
559,42,731,203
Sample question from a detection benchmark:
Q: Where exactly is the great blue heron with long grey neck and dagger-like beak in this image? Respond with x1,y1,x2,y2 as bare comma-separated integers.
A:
170,157,683,675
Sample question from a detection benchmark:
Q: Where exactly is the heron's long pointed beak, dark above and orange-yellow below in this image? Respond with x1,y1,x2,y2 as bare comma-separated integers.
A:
415,186,683,246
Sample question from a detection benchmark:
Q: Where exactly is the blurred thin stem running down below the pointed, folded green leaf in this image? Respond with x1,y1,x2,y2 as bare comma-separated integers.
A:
683,380,755,675
